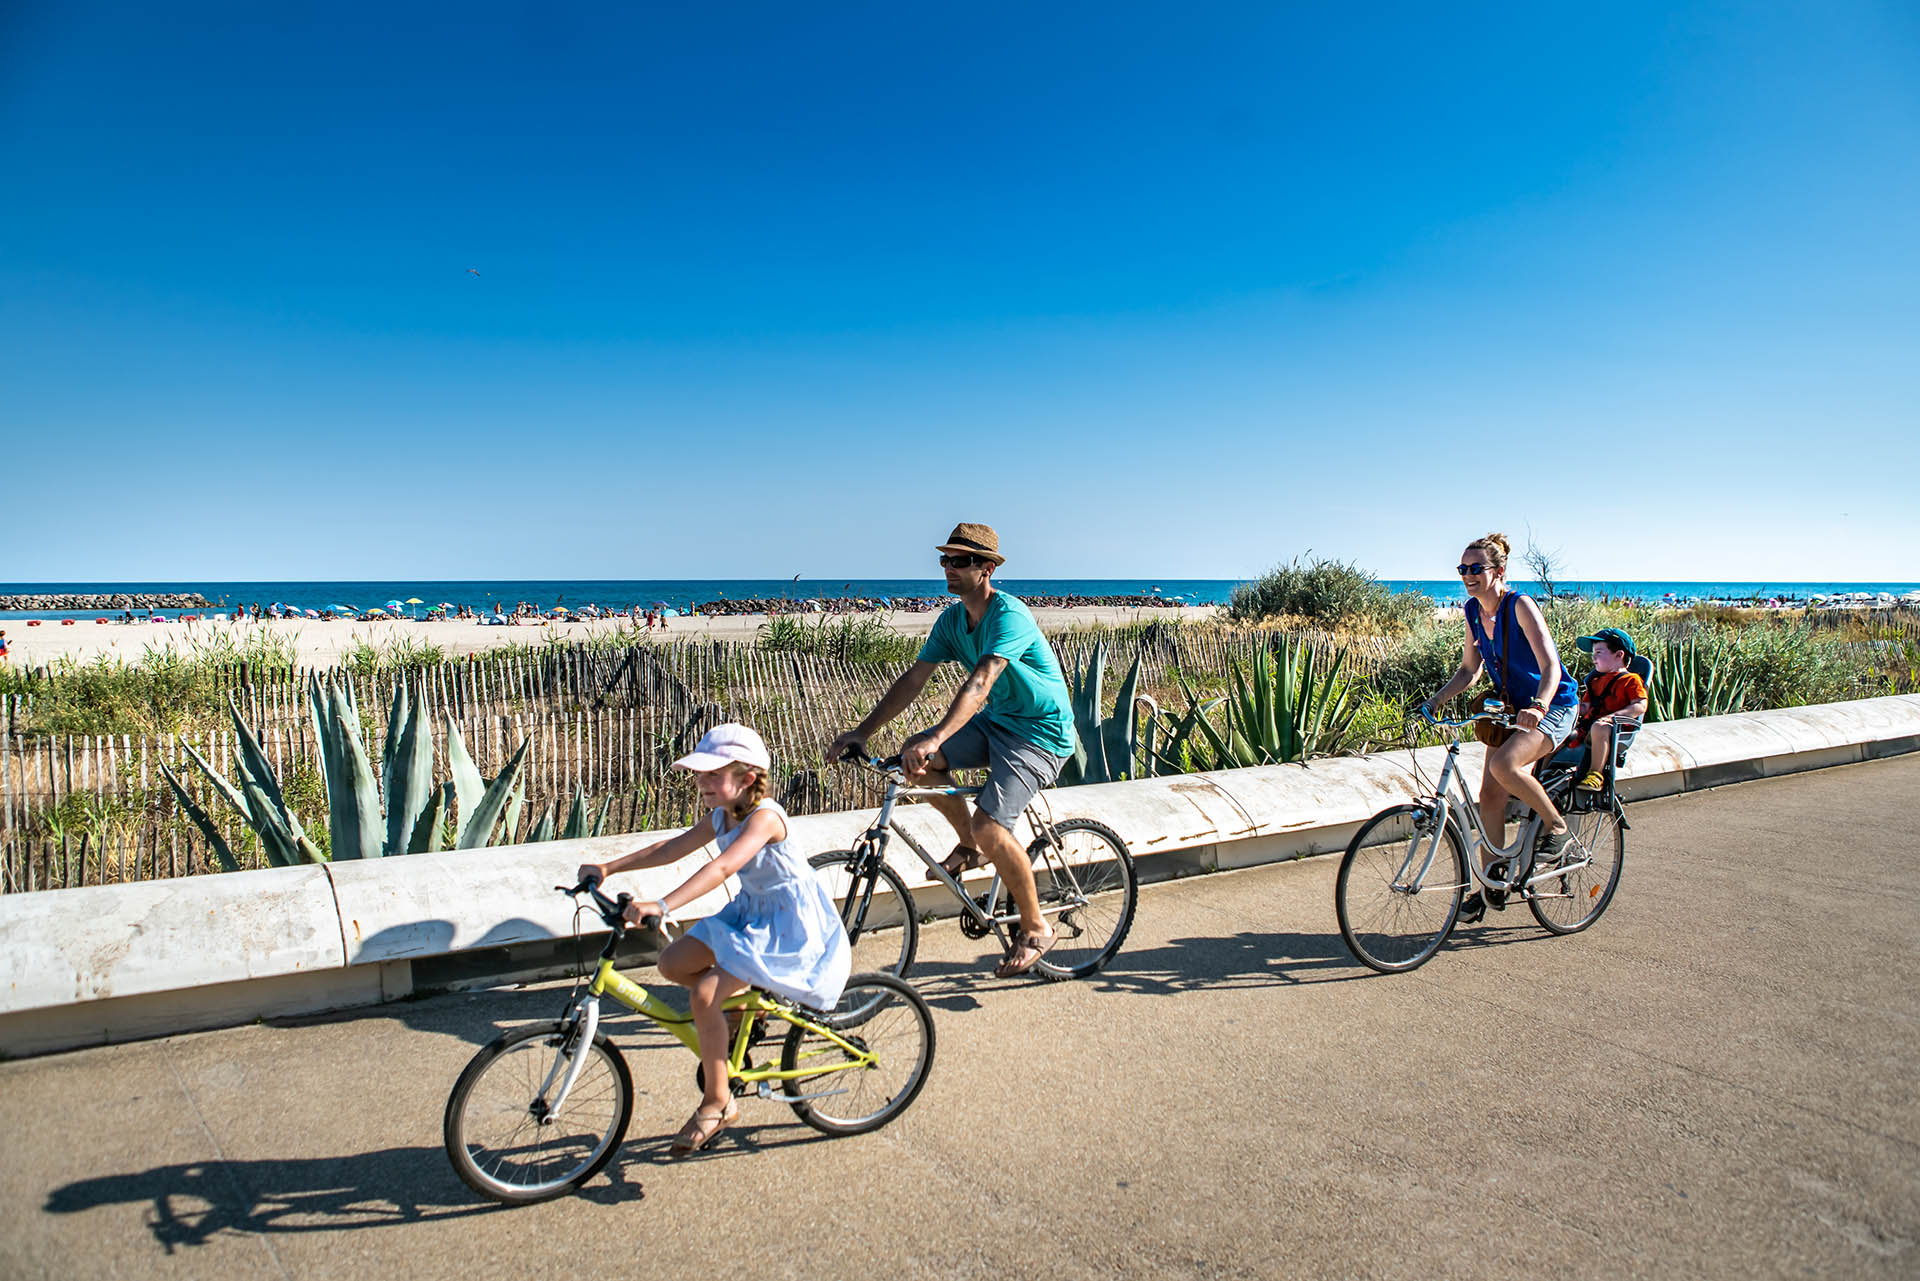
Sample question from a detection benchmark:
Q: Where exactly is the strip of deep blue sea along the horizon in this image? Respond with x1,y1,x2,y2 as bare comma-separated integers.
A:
0,576,1920,620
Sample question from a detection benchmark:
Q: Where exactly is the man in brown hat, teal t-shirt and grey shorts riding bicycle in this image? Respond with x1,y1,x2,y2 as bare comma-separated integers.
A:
828,522,1075,978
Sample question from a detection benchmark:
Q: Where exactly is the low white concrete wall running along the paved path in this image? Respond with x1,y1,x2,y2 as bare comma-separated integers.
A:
0,695,1920,1054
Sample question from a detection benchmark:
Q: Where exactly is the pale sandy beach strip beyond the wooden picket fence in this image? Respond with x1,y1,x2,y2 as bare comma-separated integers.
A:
0,605,1217,666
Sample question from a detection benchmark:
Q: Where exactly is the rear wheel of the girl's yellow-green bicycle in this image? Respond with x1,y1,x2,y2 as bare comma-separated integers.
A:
780,974,933,1135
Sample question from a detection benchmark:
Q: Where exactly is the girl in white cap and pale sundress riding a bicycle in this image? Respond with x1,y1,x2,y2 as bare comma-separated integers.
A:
580,724,852,1152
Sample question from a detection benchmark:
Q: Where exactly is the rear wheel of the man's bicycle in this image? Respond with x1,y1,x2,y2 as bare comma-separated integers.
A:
1027,818,1140,979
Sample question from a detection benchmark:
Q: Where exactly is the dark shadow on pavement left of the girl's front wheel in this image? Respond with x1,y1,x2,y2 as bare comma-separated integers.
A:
42,1147,541,1254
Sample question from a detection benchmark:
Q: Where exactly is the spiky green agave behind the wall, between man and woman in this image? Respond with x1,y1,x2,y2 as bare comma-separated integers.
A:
1188,636,1359,770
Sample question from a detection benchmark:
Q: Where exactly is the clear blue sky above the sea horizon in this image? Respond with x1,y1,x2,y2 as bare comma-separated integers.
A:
0,0,1920,580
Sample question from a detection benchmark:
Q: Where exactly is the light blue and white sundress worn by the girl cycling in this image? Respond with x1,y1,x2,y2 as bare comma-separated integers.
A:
687,801,852,1010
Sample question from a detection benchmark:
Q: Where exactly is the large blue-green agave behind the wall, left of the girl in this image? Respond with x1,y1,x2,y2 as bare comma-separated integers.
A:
159,678,532,870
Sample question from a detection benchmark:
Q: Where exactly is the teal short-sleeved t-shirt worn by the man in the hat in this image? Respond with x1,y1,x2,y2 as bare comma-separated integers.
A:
920,592,1075,757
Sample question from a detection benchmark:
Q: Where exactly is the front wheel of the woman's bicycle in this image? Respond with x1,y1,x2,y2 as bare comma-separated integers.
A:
1332,805,1469,974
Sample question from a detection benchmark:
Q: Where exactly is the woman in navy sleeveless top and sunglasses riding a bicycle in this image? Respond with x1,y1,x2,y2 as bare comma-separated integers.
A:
1428,534,1580,924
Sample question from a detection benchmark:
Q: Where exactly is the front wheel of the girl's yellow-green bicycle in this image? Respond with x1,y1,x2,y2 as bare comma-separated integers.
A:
442,1024,634,1204
